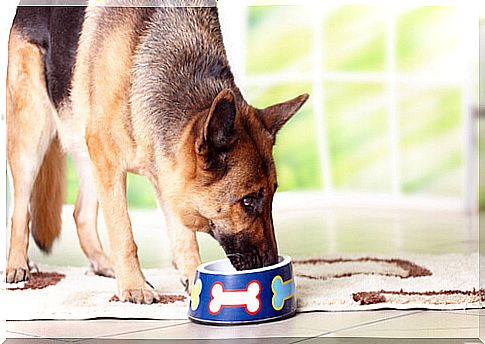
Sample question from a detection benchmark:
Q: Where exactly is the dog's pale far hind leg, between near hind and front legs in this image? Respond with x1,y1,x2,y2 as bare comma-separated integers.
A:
73,152,114,277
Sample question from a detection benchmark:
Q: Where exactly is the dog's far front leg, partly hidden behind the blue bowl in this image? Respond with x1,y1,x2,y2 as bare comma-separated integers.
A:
163,207,201,294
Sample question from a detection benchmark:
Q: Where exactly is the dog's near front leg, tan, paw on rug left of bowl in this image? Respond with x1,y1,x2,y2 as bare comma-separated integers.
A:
87,137,159,304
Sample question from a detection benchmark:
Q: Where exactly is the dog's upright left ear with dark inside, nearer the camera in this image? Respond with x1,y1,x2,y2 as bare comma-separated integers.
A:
195,89,236,169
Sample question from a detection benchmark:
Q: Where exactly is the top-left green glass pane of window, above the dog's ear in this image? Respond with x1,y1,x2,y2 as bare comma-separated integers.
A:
246,6,313,74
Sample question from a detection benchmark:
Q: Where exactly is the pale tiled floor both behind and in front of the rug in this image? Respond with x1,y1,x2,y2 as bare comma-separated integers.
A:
2,203,485,344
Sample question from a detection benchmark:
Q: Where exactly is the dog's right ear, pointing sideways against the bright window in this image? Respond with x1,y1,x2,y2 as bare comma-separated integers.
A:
261,93,310,136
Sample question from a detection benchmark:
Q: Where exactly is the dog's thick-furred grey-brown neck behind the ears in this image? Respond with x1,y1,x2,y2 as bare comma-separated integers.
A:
132,7,243,156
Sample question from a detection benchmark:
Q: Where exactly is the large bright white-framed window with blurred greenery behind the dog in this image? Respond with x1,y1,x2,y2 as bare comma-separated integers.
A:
220,0,477,208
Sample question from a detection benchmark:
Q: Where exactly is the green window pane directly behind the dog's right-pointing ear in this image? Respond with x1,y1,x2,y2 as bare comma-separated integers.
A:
246,83,322,191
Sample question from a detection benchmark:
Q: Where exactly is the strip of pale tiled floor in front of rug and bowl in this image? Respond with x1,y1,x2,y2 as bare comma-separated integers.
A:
7,310,485,344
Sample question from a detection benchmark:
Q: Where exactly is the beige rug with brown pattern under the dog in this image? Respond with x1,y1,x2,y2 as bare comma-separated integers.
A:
1,254,485,320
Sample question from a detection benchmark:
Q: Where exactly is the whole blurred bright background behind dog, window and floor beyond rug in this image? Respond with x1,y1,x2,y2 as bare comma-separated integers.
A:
2,0,485,267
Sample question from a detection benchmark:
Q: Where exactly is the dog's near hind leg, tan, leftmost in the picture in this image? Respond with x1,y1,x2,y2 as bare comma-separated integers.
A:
6,32,55,282
